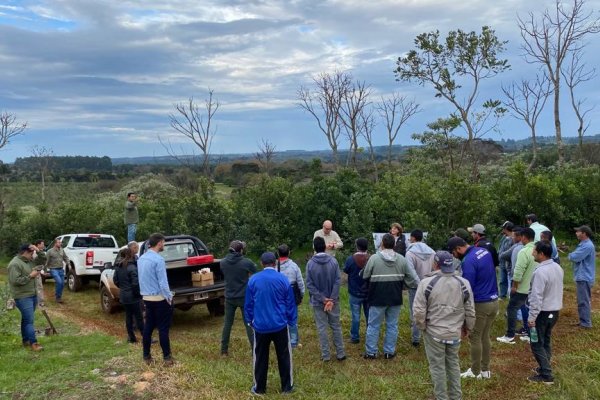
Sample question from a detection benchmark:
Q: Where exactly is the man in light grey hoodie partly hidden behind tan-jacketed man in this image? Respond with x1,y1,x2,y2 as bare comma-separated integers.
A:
406,229,435,347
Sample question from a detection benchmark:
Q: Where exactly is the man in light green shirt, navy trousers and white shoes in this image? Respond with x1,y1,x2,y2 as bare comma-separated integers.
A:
496,228,537,344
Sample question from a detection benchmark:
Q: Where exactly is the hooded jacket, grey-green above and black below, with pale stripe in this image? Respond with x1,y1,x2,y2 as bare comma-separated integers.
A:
362,249,419,307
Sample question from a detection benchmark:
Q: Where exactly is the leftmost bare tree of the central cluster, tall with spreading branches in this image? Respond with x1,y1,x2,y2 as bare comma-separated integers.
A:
298,71,352,166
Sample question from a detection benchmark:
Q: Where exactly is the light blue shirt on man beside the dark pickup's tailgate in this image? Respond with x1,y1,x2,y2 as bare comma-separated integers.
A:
138,249,173,302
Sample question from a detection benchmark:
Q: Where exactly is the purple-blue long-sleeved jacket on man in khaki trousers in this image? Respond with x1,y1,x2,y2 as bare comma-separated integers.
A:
462,246,498,303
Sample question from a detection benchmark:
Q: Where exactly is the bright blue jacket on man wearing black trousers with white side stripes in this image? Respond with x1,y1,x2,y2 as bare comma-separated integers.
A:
244,267,298,333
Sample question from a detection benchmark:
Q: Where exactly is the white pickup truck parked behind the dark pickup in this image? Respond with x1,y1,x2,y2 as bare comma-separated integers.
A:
56,233,119,292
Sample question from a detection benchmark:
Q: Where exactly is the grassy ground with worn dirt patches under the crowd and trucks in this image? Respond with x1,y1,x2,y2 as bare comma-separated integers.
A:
0,258,600,400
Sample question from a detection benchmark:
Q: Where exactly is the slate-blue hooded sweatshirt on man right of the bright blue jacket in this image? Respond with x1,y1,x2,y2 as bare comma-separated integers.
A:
306,253,341,306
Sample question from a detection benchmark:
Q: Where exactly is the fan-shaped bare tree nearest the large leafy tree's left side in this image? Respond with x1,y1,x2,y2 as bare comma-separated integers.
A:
376,92,421,168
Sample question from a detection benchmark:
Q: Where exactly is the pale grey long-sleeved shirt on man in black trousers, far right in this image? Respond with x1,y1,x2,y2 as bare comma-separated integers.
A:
527,260,564,322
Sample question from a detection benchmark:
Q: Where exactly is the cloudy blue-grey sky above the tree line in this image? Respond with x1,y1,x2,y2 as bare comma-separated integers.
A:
0,0,600,162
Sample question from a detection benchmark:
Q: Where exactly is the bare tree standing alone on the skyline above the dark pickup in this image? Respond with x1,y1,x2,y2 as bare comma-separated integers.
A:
169,88,221,176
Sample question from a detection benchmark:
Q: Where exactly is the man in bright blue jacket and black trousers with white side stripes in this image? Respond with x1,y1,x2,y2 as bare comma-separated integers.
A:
244,252,298,394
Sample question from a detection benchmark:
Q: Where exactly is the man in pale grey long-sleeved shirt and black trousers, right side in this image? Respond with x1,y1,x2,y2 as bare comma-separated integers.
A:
527,240,564,384
